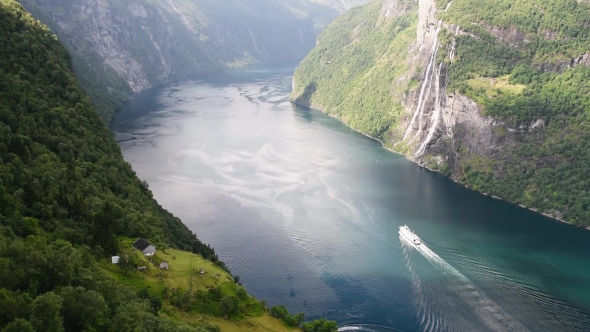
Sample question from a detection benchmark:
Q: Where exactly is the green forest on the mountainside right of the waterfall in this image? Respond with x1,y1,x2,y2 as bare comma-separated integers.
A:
441,0,590,227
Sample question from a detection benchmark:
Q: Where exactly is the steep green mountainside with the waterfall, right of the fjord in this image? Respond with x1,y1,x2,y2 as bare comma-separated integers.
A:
292,0,590,227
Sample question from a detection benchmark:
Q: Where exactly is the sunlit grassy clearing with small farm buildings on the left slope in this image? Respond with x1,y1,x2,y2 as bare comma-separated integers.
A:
101,239,301,331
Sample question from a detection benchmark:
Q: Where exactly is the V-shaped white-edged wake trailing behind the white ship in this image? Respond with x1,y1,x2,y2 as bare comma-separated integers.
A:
400,236,528,332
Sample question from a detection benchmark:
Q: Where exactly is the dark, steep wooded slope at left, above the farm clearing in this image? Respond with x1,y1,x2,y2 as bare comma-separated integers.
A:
0,1,219,257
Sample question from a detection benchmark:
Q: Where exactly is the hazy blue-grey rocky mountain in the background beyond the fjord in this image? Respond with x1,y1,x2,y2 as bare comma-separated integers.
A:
15,0,338,122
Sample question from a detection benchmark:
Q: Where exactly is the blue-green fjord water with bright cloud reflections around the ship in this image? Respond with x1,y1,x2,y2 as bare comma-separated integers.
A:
112,68,590,331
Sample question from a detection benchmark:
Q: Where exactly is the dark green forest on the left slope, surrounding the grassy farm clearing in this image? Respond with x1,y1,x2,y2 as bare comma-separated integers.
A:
0,0,338,332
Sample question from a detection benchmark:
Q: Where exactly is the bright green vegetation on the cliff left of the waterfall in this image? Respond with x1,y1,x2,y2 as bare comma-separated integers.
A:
293,1,417,140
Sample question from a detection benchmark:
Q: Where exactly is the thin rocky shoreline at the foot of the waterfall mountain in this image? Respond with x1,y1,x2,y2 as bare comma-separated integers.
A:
289,97,590,230
